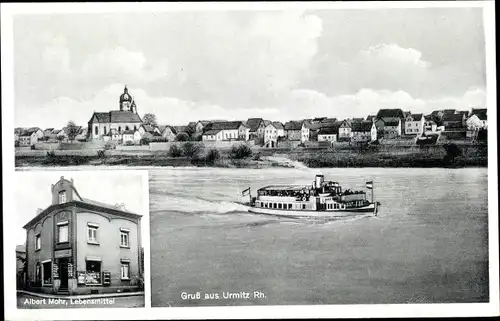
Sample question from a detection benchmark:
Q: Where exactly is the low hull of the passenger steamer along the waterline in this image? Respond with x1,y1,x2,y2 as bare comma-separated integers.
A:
248,203,377,218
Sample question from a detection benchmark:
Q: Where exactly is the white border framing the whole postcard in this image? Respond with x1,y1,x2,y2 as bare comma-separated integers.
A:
1,1,500,320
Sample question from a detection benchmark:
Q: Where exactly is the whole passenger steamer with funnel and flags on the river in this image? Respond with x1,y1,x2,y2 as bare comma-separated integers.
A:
242,175,380,217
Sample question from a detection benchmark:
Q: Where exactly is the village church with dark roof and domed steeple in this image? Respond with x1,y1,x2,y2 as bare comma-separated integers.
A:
87,86,142,140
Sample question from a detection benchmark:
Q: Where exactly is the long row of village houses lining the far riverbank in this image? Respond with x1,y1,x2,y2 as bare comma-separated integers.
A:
15,109,487,148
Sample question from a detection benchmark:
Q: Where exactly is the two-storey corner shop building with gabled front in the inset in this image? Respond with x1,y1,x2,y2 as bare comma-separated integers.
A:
24,177,143,295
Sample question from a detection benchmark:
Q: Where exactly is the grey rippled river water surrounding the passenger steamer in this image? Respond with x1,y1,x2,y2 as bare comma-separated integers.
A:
150,168,489,306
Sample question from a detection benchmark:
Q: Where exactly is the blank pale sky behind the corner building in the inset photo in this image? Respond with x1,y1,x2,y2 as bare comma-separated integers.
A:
14,170,149,244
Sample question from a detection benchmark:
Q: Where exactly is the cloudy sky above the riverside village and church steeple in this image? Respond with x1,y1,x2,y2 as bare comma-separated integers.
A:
14,8,487,128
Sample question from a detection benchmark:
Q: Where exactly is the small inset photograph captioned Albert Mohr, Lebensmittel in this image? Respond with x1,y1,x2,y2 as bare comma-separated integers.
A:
14,171,148,309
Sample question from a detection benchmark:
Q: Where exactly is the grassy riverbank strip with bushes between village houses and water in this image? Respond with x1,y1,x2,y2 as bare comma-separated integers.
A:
15,145,488,168
